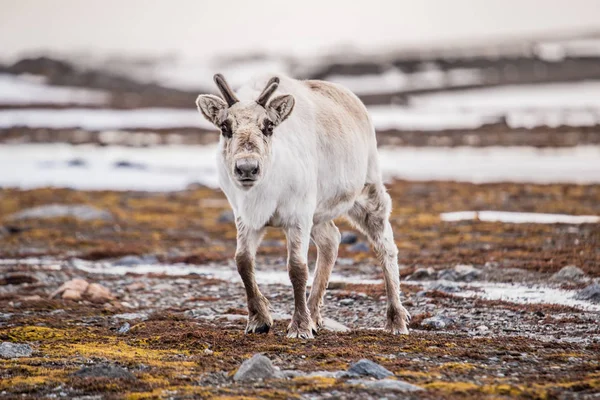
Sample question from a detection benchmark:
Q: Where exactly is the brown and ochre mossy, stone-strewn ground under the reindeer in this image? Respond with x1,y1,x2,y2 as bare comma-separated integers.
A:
0,181,600,399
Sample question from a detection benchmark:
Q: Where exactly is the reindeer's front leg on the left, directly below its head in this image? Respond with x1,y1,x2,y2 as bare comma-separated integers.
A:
235,219,273,333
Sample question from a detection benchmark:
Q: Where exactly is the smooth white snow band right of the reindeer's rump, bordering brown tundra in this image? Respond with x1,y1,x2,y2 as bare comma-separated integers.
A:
379,146,600,184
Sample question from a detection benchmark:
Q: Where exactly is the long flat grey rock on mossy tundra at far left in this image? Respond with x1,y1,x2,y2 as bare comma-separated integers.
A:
8,204,113,221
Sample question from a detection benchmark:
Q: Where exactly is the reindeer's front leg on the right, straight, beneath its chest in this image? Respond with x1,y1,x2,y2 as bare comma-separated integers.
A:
286,223,316,339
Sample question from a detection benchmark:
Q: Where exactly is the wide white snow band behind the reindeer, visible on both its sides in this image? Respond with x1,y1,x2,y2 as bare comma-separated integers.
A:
0,143,600,191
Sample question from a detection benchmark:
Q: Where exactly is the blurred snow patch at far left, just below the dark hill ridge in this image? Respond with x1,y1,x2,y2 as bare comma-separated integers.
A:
0,74,110,105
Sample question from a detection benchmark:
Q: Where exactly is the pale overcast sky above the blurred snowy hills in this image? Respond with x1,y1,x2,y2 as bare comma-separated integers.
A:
0,0,600,58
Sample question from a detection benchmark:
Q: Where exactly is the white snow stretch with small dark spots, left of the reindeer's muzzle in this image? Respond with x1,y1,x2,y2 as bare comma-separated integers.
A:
0,144,218,191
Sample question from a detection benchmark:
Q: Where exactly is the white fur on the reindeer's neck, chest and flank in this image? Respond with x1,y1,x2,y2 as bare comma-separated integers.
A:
218,77,380,229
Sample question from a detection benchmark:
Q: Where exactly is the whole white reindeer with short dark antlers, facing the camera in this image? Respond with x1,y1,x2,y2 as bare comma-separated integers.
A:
196,74,410,339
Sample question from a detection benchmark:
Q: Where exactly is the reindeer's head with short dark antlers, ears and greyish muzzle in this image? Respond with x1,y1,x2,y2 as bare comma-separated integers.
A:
196,74,294,189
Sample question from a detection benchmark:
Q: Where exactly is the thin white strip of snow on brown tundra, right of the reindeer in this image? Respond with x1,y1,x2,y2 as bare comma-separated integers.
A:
440,211,600,224
